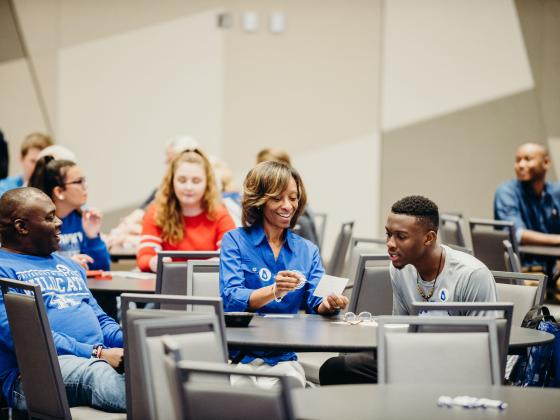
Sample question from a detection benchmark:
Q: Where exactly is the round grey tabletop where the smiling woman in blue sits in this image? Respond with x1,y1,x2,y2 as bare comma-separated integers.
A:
226,314,554,352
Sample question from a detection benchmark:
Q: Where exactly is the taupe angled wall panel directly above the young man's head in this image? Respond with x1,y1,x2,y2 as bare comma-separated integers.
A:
380,92,545,228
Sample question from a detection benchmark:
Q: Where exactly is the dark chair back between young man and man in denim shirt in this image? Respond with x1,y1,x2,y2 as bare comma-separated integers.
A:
469,219,517,271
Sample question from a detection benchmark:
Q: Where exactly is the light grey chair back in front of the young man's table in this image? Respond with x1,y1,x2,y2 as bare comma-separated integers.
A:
377,316,505,385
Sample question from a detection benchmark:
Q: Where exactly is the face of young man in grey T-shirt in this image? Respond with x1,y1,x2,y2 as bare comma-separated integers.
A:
385,213,434,269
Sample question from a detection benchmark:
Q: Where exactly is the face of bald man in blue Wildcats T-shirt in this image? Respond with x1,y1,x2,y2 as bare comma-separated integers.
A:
22,196,62,257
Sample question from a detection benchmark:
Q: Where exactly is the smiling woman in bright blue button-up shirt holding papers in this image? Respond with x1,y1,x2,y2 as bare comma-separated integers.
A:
220,161,348,387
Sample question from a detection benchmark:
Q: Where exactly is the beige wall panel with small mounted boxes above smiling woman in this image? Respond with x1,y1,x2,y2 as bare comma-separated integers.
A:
223,0,380,178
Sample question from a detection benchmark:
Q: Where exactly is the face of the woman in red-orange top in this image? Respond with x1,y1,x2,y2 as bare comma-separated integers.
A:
173,162,207,209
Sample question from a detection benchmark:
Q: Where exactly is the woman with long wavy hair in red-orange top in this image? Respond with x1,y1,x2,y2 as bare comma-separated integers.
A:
136,149,235,271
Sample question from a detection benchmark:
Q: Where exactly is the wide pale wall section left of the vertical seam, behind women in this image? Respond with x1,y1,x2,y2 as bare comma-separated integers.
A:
3,0,381,251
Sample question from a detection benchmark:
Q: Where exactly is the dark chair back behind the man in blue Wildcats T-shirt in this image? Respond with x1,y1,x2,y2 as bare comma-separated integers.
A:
0,279,71,419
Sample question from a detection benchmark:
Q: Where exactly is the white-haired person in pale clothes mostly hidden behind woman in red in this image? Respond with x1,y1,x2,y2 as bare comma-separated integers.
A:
106,136,198,249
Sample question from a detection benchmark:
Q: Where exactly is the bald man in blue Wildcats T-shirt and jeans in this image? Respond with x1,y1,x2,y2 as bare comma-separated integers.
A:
0,187,126,412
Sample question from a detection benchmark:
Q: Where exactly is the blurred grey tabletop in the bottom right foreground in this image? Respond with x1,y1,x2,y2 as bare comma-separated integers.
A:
292,384,560,420
